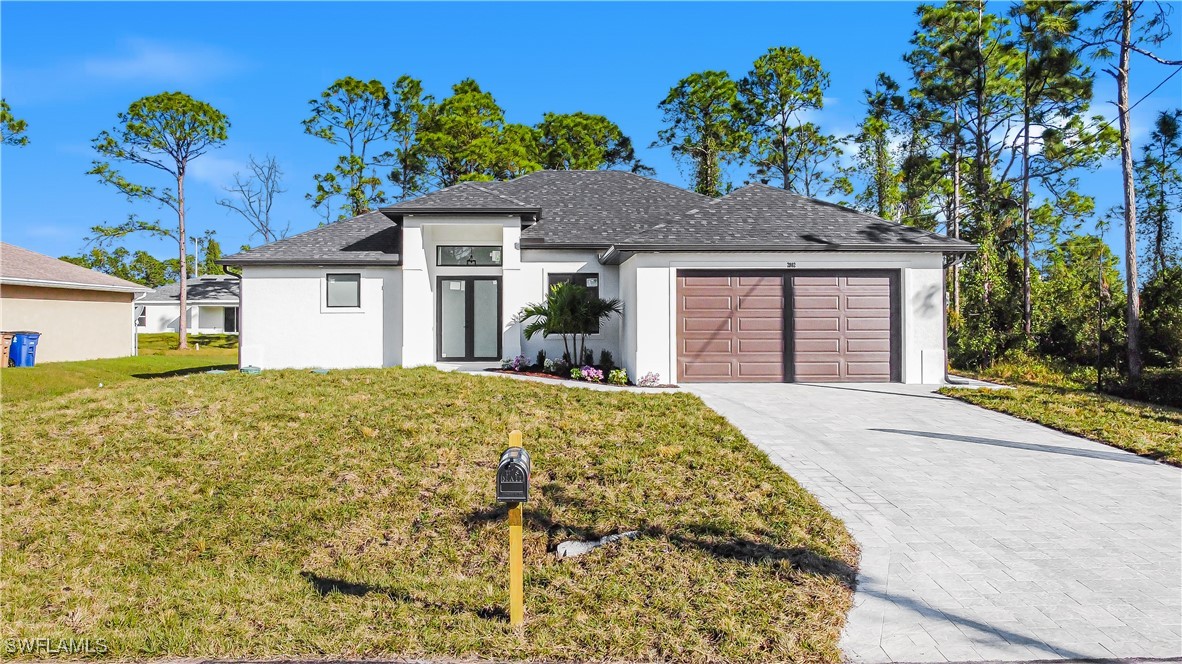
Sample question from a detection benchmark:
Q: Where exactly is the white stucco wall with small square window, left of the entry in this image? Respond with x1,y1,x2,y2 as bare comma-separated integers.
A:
240,266,402,369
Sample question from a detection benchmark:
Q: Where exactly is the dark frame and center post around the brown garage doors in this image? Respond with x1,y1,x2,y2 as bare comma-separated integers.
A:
674,267,903,383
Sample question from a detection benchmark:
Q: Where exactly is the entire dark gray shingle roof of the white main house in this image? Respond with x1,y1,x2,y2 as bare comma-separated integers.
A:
225,170,975,265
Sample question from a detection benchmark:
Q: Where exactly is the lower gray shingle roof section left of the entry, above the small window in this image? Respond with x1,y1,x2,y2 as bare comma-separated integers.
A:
219,211,401,265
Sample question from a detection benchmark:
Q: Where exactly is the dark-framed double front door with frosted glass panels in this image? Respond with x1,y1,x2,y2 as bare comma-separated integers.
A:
435,276,501,362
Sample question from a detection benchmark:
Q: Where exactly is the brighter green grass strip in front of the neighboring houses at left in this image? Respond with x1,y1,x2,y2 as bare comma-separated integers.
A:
0,333,238,406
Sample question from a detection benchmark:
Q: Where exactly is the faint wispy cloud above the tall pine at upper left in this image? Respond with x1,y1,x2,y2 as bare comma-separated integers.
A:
79,39,241,84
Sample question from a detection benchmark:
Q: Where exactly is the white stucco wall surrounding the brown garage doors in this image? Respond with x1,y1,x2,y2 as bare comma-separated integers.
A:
621,252,944,383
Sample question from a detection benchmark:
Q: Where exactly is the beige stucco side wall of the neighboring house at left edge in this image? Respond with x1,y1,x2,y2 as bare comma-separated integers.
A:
0,281,136,364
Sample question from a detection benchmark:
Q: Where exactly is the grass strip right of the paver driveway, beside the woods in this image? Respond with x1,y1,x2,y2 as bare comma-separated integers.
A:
940,360,1182,466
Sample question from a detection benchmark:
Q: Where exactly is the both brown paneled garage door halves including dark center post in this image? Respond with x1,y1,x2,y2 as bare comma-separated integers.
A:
676,271,900,383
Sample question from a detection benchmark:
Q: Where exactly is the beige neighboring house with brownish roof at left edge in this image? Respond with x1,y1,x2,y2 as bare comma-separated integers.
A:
0,242,150,364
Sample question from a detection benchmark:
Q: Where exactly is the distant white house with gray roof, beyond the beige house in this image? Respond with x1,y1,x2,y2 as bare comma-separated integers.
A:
136,274,239,334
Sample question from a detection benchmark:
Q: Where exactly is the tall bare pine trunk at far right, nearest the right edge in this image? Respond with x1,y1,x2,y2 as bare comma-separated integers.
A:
1116,0,1141,383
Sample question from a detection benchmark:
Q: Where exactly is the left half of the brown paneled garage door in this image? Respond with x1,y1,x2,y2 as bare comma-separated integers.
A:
677,273,784,383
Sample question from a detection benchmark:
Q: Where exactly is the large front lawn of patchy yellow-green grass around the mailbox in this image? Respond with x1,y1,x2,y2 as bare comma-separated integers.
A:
0,369,857,663
